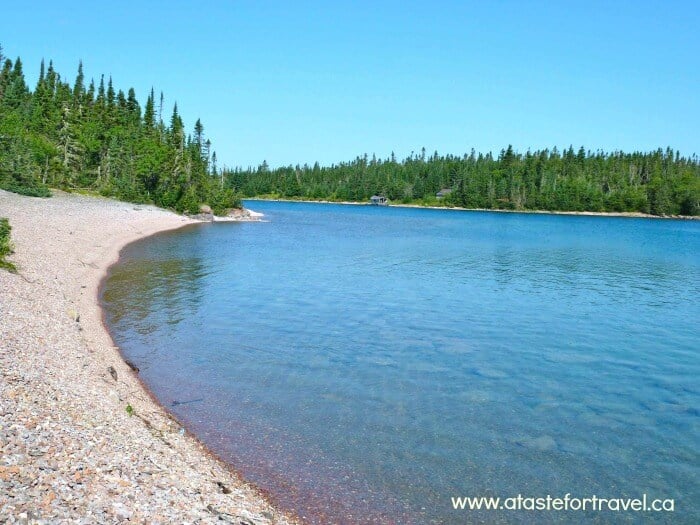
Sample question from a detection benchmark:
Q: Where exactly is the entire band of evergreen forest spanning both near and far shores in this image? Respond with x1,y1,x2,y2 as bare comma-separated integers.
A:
0,44,700,216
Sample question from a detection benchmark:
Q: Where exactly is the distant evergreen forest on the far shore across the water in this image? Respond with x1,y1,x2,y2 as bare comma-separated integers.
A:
231,146,700,215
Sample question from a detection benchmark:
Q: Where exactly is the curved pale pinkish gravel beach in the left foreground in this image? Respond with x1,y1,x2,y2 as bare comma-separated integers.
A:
0,190,296,525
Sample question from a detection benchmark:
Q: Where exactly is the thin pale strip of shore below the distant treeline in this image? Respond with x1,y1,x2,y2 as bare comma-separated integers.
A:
243,197,700,221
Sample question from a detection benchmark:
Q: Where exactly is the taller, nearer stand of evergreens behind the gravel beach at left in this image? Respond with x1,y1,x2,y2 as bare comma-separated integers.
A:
0,48,240,214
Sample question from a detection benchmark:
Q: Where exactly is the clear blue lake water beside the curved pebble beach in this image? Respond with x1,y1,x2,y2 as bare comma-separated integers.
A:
102,202,700,523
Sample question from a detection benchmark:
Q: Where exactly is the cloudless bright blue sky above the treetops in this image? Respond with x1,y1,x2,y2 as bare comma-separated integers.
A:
0,0,700,166
